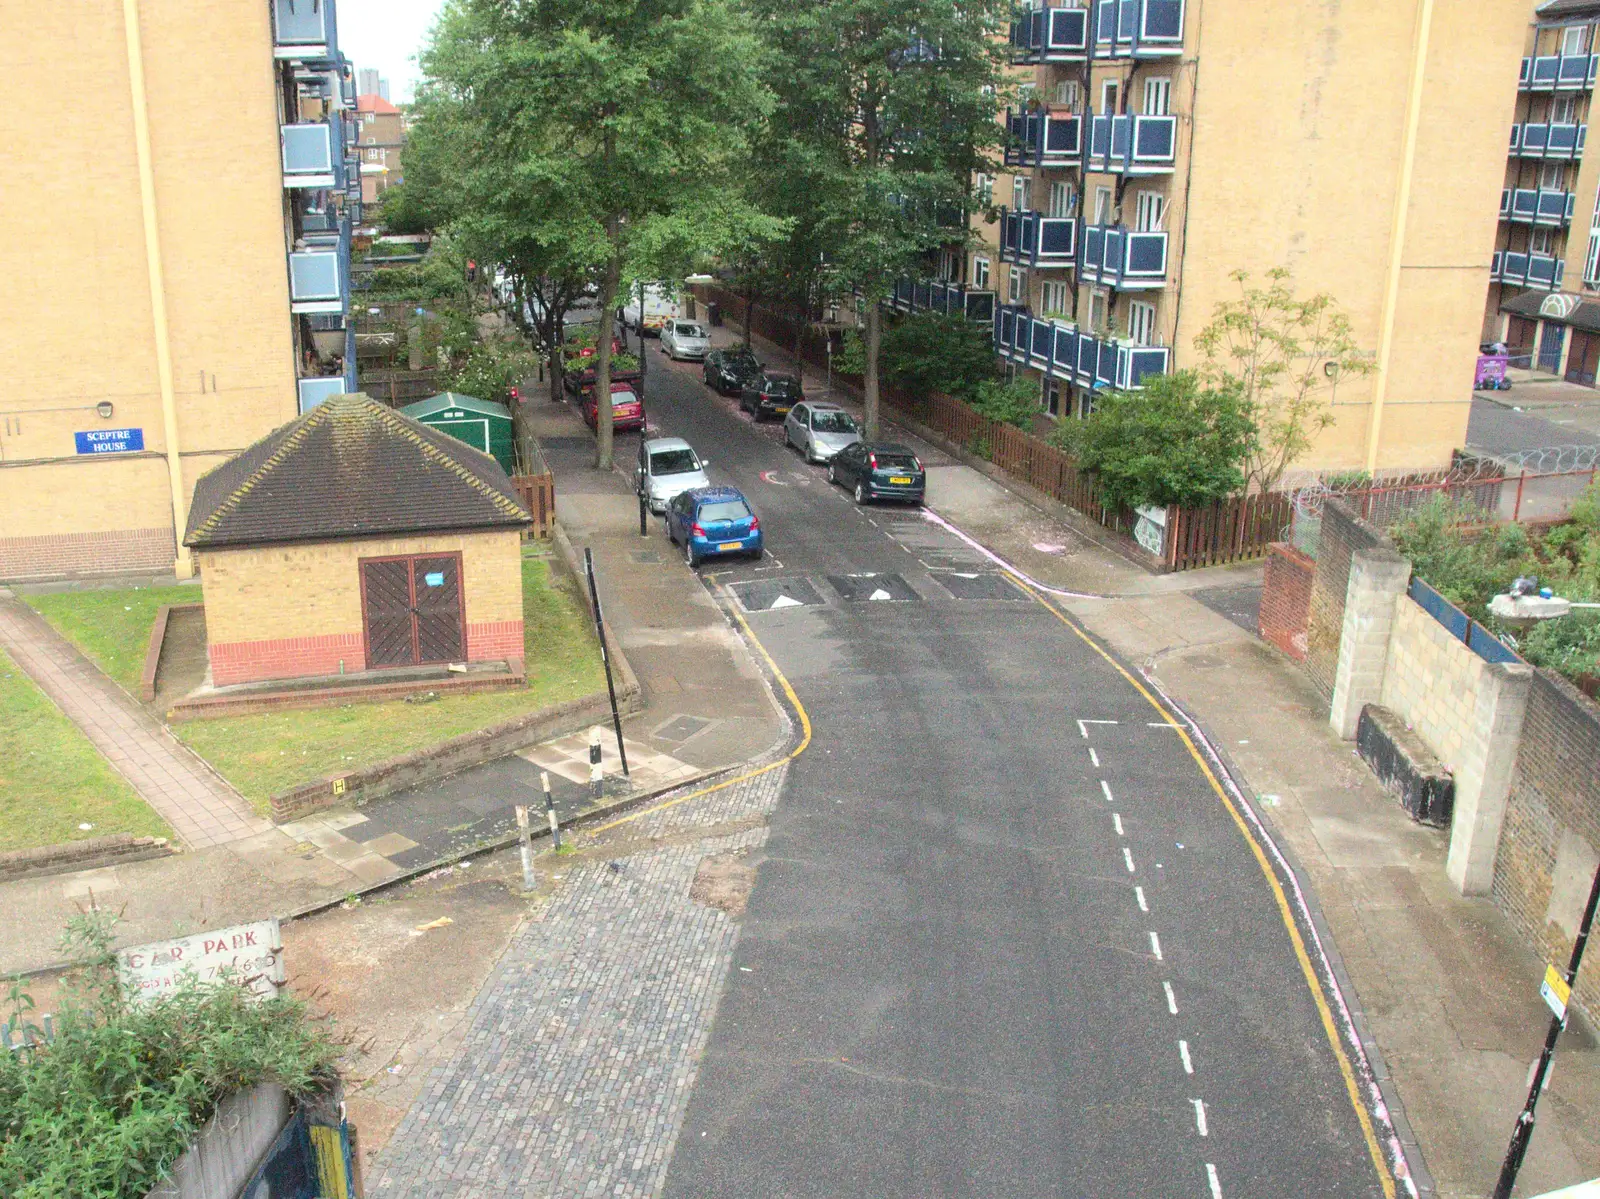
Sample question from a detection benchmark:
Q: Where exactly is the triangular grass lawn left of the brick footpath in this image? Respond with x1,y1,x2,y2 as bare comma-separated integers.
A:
0,650,173,850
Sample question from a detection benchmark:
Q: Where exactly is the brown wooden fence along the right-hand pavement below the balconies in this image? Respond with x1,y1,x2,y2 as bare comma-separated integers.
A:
696,287,1293,570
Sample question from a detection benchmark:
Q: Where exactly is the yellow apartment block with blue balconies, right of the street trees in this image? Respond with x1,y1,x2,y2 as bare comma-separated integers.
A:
896,0,1531,471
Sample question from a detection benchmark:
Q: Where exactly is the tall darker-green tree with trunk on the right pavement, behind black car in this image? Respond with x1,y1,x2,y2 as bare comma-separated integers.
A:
746,0,1011,437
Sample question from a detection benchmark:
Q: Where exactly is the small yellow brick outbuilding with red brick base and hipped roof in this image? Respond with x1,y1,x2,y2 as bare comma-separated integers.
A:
184,395,531,687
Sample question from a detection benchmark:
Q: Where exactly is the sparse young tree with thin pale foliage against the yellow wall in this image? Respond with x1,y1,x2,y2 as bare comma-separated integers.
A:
1195,267,1373,491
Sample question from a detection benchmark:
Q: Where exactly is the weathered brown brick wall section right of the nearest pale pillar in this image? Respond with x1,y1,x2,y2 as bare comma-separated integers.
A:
1491,669,1600,1025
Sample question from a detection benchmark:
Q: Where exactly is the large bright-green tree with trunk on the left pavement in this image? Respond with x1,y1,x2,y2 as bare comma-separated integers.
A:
408,0,771,469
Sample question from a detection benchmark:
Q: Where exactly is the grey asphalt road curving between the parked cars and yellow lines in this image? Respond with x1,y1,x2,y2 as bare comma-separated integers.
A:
624,339,1384,1199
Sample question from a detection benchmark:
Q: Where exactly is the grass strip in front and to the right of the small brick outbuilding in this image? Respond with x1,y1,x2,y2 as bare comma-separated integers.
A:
173,557,605,812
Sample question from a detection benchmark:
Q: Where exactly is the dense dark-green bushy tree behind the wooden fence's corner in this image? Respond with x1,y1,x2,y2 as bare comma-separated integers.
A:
1051,370,1256,507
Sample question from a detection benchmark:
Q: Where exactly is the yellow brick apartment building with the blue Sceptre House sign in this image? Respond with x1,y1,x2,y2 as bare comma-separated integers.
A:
0,0,360,581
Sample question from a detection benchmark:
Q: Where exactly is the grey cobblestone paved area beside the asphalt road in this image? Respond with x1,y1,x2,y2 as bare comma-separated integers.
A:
370,767,787,1199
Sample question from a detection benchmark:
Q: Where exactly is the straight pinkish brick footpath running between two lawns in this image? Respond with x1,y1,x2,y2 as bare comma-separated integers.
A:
0,599,272,848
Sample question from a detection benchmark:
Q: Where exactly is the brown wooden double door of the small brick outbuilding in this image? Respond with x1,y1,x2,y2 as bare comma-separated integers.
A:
362,554,466,669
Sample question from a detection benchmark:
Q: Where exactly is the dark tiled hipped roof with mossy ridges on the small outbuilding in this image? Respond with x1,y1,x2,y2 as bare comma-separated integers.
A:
184,395,531,547
